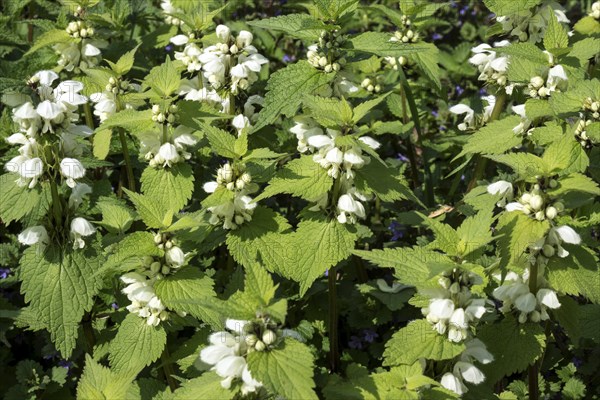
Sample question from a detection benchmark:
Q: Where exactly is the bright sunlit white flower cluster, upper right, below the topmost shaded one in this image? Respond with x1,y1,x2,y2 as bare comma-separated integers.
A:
469,40,514,94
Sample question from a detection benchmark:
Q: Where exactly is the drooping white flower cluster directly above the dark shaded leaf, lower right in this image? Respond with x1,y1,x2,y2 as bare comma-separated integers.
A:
493,270,560,324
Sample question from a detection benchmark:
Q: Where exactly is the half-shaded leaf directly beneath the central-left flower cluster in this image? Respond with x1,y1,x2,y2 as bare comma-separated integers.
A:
227,206,291,270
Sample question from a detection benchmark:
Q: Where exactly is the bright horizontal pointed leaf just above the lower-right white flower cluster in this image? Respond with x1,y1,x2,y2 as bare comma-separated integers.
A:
353,247,452,285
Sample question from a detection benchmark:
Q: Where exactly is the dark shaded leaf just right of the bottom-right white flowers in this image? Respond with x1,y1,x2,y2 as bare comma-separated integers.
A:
477,316,546,382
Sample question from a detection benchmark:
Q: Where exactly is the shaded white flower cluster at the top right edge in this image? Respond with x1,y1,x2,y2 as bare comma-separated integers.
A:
496,2,569,43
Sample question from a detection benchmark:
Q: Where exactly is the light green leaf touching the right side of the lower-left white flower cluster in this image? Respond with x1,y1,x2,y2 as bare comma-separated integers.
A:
154,266,221,328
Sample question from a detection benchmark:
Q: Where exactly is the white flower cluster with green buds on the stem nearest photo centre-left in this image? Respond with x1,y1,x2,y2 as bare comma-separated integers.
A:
204,163,258,229
